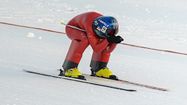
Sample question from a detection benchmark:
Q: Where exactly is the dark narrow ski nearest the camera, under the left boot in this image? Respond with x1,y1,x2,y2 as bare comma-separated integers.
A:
23,69,137,92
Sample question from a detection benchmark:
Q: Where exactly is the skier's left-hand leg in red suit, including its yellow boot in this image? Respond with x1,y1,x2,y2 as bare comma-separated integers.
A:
59,28,89,79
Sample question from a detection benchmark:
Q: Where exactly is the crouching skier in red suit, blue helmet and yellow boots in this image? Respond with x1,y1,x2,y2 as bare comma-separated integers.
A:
59,12,123,79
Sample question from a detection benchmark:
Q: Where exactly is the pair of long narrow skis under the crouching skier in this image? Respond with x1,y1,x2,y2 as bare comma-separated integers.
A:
23,69,168,92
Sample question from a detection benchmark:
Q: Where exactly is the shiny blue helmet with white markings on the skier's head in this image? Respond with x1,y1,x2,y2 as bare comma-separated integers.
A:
92,16,119,38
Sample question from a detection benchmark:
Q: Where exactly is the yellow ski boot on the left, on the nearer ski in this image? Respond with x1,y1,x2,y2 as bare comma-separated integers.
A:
59,68,86,80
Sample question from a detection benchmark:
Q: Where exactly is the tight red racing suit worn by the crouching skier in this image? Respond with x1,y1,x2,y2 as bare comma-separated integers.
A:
63,12,116,70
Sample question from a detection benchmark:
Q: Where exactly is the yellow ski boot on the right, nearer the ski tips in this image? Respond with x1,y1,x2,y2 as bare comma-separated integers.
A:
95,67,118,80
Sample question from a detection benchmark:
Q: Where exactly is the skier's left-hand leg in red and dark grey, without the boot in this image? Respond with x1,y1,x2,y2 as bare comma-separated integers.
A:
62,27,89,70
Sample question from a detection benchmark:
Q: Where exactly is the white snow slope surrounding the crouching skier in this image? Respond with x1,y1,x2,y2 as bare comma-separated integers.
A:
0,0,187,105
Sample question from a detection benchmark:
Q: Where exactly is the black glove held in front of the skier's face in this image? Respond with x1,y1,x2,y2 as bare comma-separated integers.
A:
107,35,124,43
